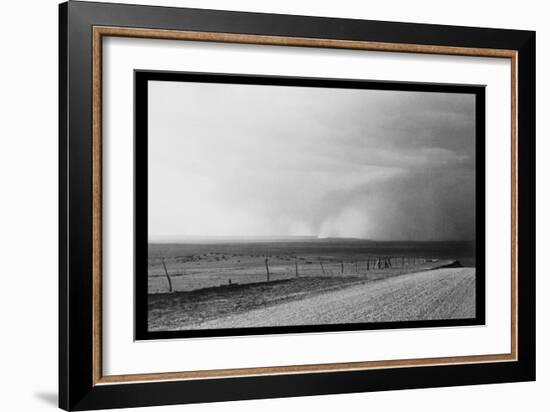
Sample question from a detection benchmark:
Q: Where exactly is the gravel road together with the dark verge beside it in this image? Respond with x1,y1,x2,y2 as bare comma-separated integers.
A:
149,268,475,331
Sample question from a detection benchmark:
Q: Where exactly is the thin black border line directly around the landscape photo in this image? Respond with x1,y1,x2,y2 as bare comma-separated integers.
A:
134,70,486,340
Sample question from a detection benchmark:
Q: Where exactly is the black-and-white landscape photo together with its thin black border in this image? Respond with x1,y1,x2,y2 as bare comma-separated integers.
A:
135,72,484,339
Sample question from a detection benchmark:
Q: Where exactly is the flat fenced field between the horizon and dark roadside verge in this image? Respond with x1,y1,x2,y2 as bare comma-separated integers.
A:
148,238,475,294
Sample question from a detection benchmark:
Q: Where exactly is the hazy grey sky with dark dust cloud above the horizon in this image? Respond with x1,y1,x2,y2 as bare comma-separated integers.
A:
149,81,475,241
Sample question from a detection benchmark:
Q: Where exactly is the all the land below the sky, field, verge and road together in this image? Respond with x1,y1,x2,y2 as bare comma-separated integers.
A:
147,238,475,331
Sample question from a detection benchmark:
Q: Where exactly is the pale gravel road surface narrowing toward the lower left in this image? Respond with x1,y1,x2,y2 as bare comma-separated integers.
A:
190,268,475,329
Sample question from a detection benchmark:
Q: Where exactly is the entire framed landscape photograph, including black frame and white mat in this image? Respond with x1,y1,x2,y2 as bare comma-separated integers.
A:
59,1,535,410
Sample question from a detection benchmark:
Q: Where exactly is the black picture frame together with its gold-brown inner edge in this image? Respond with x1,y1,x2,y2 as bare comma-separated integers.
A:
59,1,535,410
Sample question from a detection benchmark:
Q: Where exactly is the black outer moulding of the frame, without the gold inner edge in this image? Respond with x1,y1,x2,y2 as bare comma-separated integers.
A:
59,1,535,410
